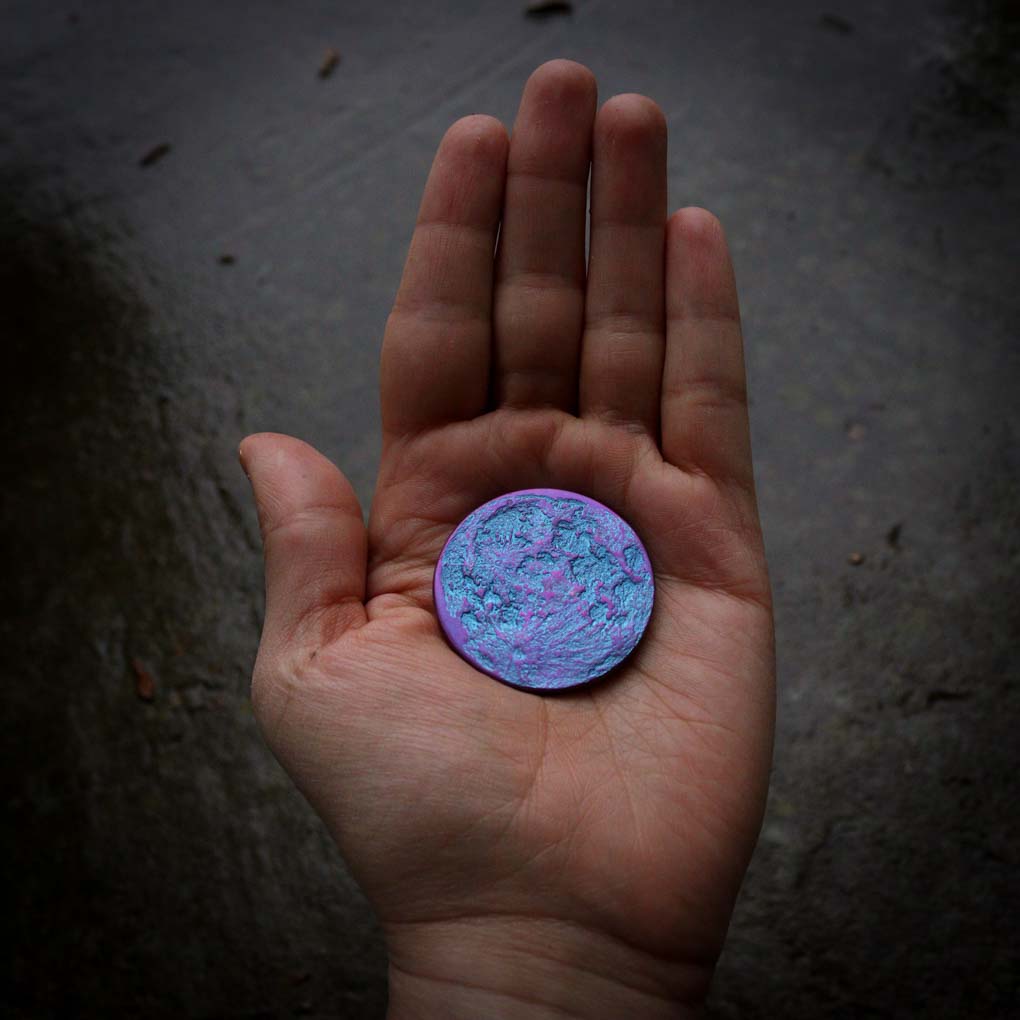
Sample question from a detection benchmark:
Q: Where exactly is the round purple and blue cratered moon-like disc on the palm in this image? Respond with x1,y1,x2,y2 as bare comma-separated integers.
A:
434,489,655,691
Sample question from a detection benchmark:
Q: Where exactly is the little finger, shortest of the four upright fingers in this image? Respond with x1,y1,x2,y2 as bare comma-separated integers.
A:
662,208,753,488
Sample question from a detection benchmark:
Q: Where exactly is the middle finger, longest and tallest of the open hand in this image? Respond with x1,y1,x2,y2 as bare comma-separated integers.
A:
494,60,596,410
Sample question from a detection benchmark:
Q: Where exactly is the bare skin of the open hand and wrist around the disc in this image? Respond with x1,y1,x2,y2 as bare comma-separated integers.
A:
241,60,774,1020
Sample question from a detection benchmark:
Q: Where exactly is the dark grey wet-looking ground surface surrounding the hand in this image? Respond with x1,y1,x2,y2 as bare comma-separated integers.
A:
0,0,1020,1020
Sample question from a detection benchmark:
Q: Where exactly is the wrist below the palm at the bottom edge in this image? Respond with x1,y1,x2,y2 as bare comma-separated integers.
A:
387,916,712,1020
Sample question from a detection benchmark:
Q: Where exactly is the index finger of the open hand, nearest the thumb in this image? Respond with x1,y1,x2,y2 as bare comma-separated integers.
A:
380,116,508,436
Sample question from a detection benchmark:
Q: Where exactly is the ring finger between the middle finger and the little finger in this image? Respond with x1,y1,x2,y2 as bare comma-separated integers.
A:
580,95,666,436
